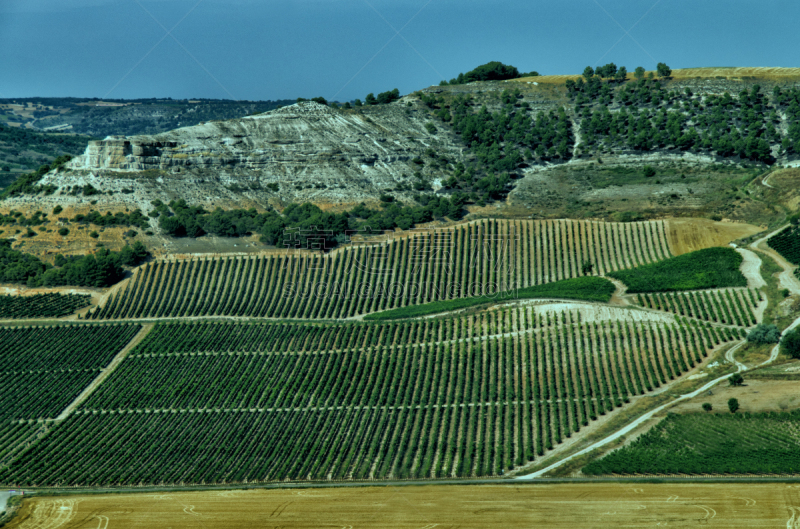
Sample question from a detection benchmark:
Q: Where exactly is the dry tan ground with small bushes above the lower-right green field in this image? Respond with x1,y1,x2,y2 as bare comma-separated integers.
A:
669,380,800,413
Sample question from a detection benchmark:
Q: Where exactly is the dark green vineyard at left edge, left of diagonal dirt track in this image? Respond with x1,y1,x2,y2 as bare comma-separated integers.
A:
0,325,140,463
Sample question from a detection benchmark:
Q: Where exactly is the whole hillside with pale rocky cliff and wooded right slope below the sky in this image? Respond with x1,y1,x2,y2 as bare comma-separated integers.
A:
0,68,800,235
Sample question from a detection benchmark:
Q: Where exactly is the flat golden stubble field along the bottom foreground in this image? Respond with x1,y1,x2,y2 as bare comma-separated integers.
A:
6,483,800,529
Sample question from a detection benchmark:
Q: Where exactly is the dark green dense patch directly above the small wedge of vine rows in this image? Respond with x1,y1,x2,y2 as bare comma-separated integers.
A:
608,248,747,294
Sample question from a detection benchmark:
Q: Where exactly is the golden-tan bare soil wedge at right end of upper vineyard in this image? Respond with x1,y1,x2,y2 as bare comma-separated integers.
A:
666,219,762,255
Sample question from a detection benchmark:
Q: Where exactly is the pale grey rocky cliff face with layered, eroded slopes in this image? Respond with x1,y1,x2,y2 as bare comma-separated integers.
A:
28,98,463,208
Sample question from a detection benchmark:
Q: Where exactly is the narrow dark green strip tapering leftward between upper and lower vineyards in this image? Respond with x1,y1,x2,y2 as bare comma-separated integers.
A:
364,277,615,320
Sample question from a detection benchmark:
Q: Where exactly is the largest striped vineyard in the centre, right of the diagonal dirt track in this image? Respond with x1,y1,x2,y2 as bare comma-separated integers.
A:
0,314,743,485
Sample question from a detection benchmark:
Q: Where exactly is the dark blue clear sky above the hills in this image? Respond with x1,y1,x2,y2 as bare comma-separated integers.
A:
0,0,800,101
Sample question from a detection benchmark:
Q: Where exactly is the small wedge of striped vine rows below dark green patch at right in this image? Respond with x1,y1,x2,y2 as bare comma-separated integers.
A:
633,288,763,327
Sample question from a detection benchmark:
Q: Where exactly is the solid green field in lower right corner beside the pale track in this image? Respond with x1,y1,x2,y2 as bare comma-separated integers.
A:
583,411,800,475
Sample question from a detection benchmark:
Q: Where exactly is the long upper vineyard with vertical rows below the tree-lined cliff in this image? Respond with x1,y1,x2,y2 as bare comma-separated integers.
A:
90,220,672,320
